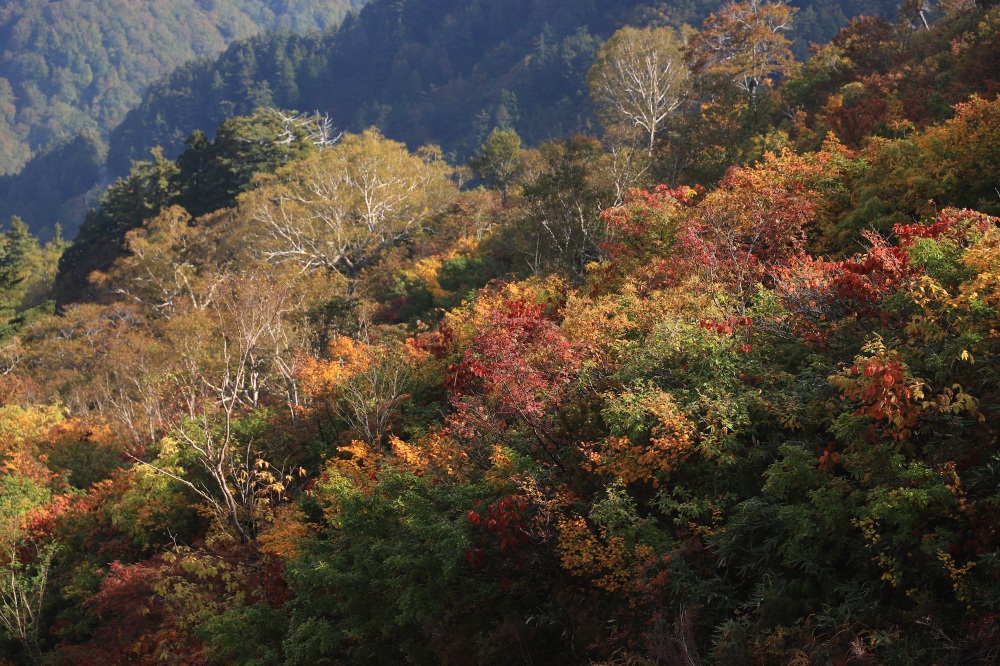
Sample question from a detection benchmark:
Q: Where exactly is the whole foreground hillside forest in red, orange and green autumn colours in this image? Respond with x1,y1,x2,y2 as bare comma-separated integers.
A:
0,0,1000,666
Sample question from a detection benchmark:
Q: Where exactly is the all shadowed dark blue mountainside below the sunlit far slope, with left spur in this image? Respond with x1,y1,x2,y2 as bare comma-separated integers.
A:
0,0,896,238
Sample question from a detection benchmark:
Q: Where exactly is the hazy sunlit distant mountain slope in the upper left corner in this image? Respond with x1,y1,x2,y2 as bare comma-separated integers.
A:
0,0,363,175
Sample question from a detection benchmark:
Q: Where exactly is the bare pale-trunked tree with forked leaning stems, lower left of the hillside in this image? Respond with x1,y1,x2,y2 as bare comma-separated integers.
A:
134,273,294,542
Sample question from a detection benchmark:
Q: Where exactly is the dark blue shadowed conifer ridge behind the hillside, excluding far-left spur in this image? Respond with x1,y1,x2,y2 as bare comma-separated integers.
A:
109,0,908,172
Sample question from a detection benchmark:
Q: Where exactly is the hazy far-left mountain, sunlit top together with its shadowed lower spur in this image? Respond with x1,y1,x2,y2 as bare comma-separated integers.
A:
0,0,363,243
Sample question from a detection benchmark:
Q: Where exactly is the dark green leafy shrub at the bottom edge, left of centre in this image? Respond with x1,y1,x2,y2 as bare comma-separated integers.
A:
285,472,475,663
